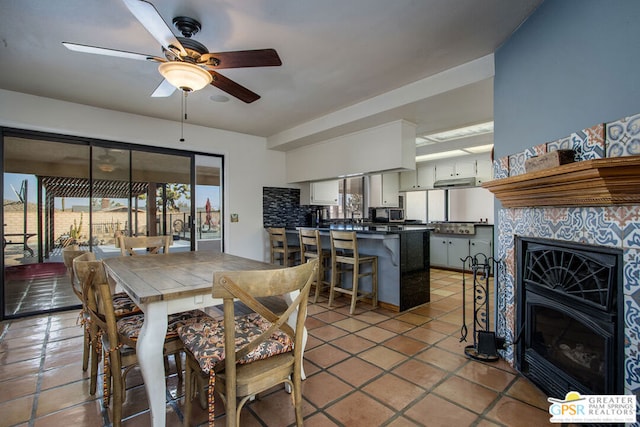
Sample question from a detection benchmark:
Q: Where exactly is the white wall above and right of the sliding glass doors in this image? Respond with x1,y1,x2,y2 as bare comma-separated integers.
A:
0,90,291,260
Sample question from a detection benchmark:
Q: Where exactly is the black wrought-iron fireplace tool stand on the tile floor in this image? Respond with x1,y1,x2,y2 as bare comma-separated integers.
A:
460,253,505,362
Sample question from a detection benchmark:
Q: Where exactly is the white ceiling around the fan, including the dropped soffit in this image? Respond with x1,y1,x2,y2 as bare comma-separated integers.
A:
0,0,542,149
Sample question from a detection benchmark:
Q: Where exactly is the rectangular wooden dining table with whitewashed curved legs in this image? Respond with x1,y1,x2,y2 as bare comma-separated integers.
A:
103,251,307,427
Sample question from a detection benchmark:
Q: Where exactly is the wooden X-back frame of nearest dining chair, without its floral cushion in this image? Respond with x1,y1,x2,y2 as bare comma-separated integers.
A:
213,260,318,426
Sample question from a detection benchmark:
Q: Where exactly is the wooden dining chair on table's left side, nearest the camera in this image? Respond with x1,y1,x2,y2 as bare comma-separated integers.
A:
73,256,206,426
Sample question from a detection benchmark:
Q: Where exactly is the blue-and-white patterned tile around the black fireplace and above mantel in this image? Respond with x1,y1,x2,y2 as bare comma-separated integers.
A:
487,114,640,400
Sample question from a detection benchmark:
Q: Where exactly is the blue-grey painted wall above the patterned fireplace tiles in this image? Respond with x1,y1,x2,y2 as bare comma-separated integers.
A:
494,0,640,158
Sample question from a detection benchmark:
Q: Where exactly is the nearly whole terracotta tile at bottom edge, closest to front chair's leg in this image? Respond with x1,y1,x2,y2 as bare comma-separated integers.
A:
325,391,395,427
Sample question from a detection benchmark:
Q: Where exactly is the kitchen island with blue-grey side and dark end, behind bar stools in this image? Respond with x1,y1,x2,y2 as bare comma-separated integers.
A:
287,224,431,311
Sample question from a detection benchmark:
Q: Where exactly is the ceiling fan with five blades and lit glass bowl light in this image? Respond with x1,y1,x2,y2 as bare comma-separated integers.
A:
62,0,282,103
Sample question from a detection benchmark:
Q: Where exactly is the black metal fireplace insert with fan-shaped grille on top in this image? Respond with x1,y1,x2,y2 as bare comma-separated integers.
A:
515,236,624,399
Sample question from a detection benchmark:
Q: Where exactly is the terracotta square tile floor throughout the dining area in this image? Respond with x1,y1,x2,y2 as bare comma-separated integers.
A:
0,270,550,427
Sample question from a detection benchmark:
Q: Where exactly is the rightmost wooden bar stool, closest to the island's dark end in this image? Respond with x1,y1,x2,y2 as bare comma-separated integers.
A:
329,230,378,314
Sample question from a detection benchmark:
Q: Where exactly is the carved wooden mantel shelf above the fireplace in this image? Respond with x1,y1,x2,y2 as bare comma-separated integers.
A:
482,156,640,208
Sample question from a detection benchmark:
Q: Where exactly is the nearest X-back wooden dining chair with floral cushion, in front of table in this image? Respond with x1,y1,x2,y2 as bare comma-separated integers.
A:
178,260,318,427
